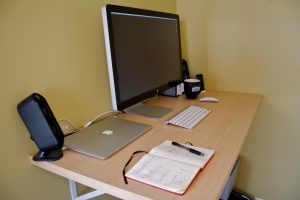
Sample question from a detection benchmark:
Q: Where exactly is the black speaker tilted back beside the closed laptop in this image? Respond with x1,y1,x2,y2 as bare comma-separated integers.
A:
17,93,64,161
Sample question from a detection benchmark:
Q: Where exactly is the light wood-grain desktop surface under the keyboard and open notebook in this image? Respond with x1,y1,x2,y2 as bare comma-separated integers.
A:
31,91,262,200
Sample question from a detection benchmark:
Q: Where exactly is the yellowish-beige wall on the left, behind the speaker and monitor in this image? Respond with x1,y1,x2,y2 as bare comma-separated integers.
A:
0,0,176,200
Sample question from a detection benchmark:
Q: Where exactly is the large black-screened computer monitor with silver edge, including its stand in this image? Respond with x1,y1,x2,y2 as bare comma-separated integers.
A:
102,5,182,118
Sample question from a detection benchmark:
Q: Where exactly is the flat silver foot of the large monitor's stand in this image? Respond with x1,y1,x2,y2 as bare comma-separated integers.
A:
124,103,172,119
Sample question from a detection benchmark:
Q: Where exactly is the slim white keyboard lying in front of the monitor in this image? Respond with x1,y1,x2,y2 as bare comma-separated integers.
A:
166,105,211,129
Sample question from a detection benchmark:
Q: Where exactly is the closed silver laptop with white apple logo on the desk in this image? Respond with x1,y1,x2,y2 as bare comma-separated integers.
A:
64,117,152,159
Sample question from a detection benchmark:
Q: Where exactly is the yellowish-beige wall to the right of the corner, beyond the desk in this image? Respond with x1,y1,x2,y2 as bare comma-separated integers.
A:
177,0,300,200
